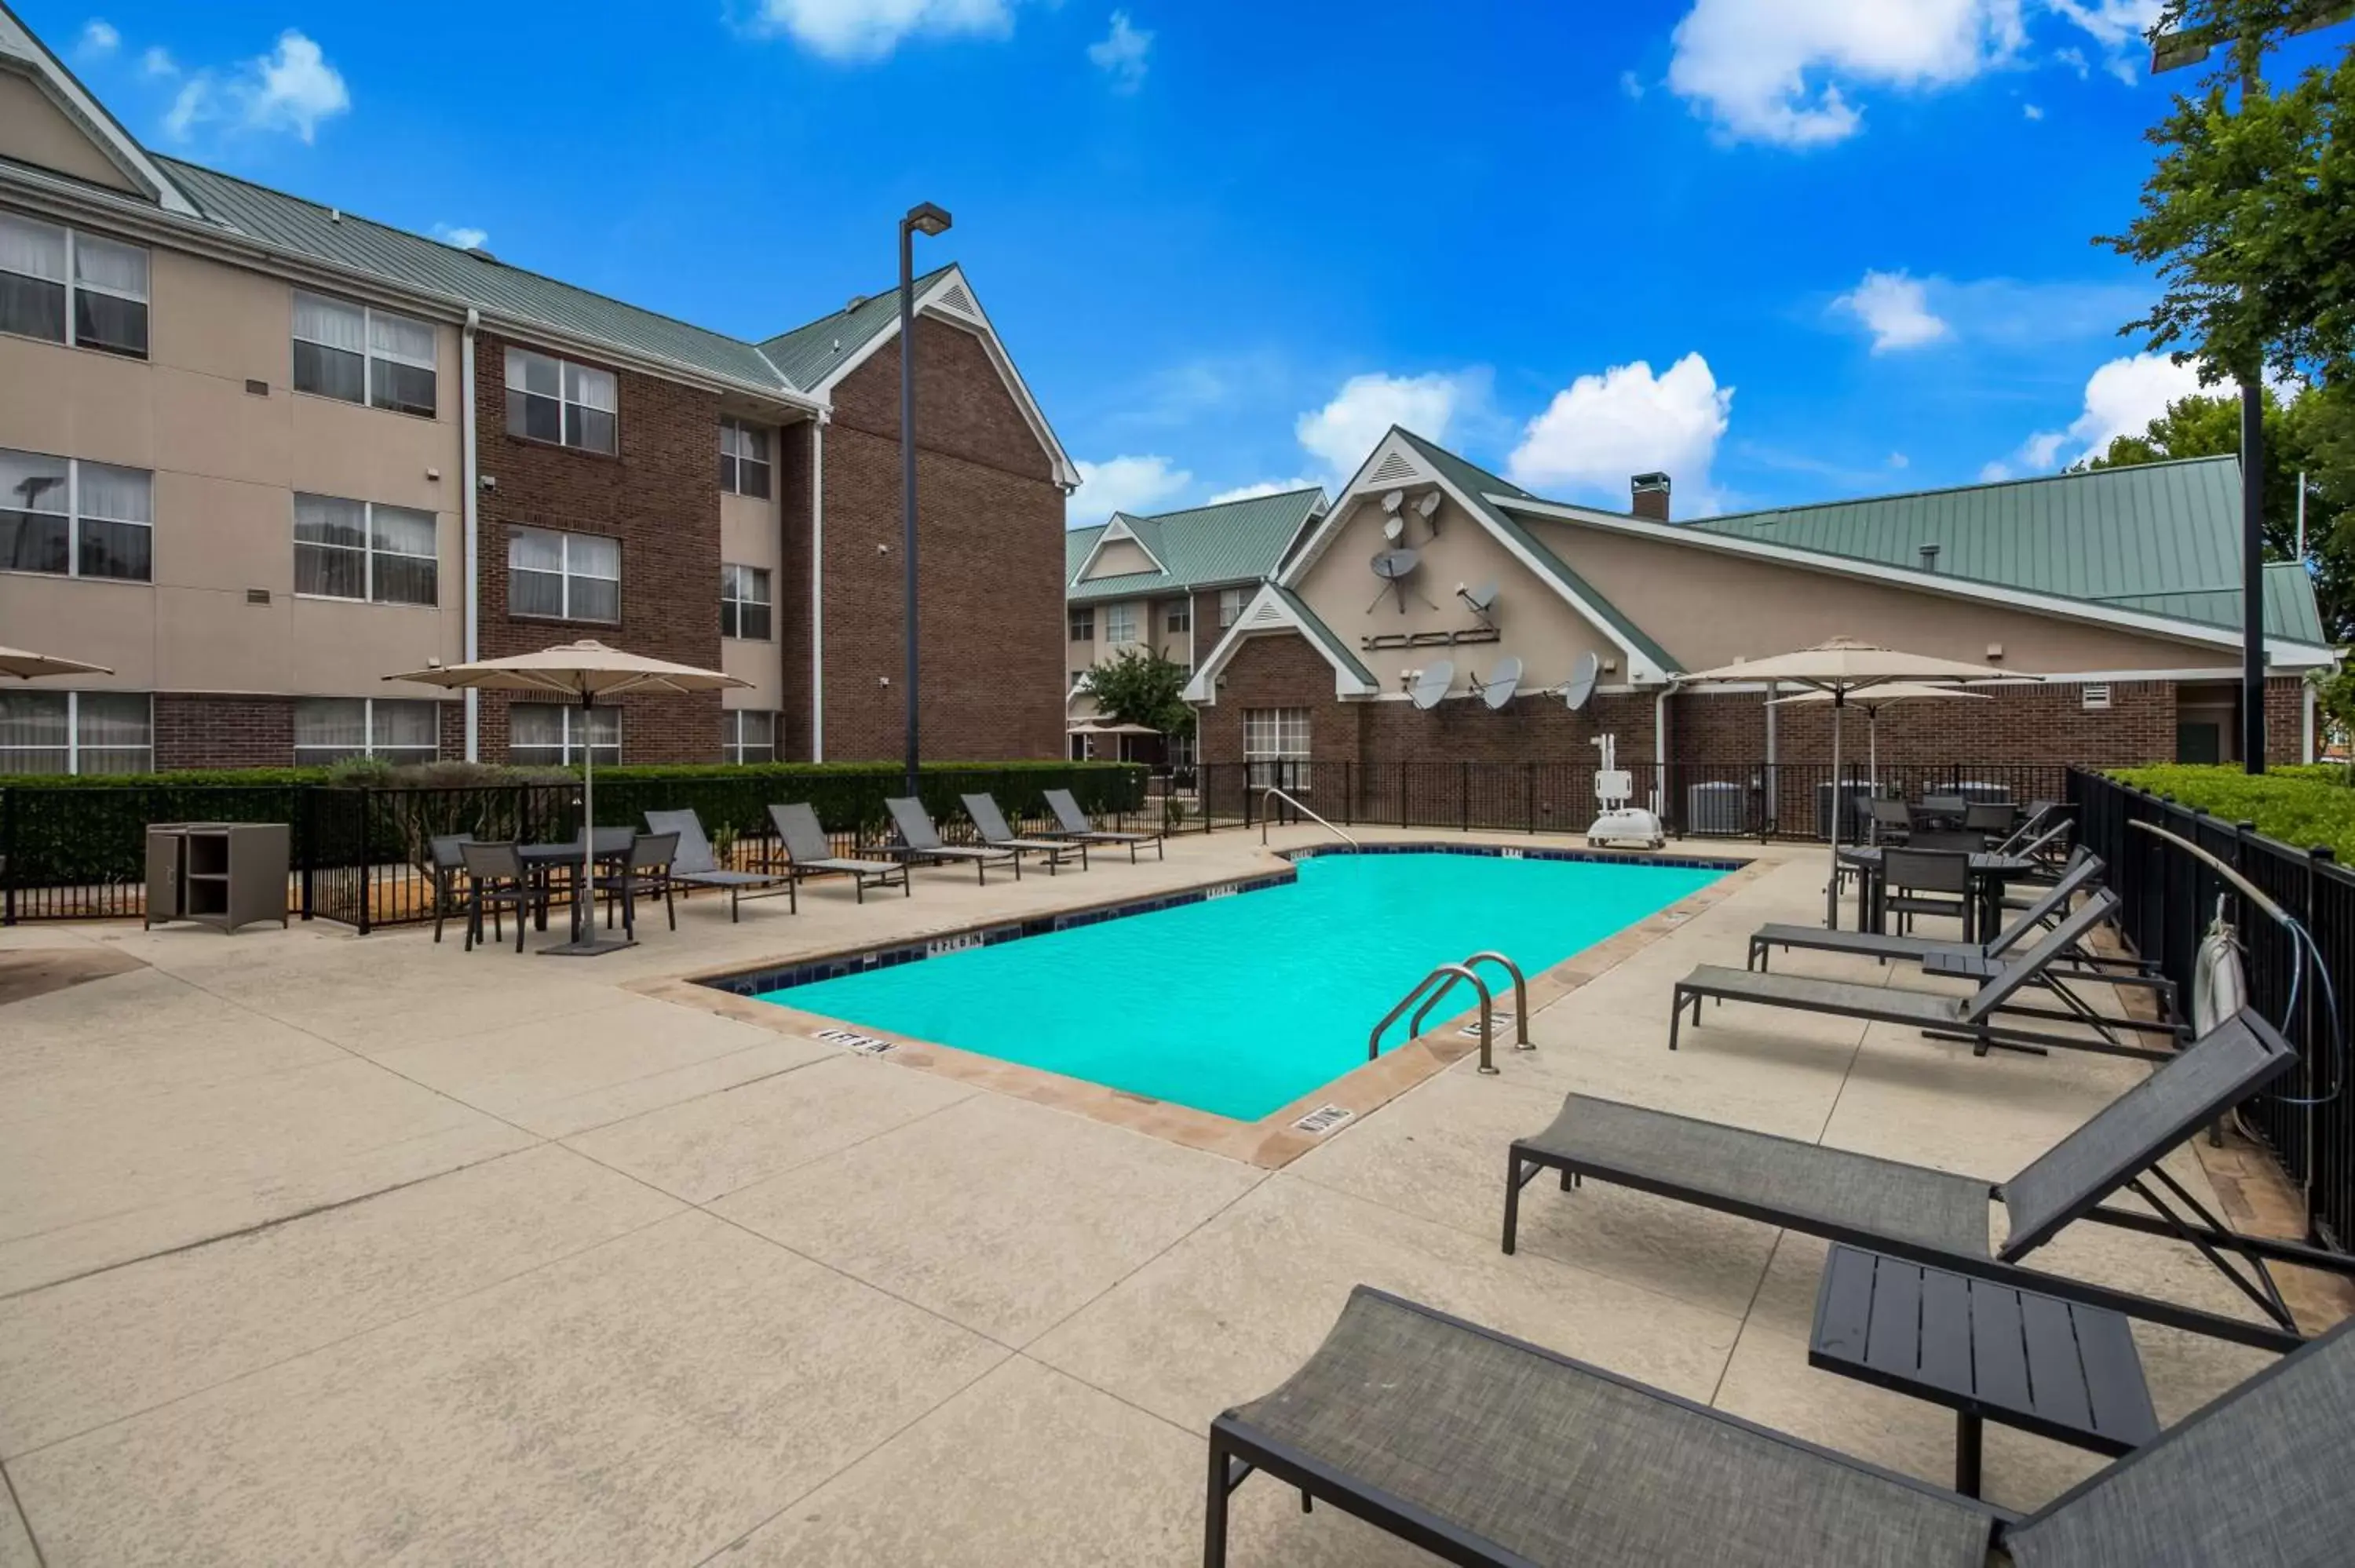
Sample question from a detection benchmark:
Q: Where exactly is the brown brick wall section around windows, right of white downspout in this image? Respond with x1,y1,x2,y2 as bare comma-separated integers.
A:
476,334,721,763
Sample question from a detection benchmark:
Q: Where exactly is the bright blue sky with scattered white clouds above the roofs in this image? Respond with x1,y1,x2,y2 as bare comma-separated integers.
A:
27,0,2346,523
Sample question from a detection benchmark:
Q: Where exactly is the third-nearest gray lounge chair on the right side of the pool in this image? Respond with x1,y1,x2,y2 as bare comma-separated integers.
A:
1667,890,2181,1062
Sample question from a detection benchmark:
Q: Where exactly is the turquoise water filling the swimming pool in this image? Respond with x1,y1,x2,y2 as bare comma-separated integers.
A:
761,855,1724,1121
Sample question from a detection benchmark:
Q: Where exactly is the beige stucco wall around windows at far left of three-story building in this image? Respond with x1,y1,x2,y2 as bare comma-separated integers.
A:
0,250,466,697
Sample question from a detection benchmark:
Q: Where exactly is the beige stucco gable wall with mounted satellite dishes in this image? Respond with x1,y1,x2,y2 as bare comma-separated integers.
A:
1293,499,1627,692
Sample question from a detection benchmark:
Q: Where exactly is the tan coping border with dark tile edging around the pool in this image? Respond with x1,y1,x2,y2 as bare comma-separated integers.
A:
629,841,1771,1170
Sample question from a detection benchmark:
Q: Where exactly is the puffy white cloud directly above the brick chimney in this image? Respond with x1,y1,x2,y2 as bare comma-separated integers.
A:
1505,353,1733,509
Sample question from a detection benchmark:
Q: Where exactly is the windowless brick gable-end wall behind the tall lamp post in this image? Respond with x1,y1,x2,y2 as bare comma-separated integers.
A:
820,320,1069,760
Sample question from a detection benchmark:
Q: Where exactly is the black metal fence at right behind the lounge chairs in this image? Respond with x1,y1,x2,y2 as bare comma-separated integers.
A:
2068,772,2355,1248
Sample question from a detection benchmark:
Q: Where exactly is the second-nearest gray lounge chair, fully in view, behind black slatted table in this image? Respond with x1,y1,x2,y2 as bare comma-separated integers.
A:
1505,1010,2355,1349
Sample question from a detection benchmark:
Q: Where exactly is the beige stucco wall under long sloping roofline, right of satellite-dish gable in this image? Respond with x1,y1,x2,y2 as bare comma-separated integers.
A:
1524,518,2235,673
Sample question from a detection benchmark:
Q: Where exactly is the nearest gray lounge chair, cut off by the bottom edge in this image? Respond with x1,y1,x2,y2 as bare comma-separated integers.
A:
1203,1285,2355,1568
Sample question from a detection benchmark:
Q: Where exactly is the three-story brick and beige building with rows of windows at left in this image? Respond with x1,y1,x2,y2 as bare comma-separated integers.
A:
0,7,1079,772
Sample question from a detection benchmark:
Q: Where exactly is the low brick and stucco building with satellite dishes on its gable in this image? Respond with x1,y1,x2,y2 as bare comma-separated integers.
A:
1187,428,2334,786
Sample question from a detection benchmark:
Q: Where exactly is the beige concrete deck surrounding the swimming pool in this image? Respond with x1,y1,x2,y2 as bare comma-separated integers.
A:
0,829,2331,1568
